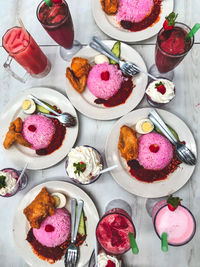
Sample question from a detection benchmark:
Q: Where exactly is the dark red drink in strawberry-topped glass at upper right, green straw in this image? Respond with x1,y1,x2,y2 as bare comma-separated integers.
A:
155,22,194,73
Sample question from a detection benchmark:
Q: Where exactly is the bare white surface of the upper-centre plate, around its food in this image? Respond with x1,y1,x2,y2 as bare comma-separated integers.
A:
66,41,147,120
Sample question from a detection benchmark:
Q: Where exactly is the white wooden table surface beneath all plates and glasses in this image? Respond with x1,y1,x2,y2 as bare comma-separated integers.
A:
0,0,200,267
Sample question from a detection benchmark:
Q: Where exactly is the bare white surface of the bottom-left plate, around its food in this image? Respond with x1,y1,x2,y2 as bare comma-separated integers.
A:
13,181,99,267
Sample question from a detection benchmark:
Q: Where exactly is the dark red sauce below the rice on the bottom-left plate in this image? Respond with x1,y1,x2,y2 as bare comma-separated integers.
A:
26,228,86,264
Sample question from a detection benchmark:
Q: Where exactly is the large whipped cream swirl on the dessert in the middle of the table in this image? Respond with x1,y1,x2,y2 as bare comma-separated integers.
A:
67,146,102,184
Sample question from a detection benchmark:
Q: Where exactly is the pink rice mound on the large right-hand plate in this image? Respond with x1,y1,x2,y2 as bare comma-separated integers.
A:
138,133,173,170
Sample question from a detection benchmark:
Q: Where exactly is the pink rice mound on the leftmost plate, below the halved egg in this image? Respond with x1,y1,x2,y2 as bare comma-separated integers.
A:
22,114,55,149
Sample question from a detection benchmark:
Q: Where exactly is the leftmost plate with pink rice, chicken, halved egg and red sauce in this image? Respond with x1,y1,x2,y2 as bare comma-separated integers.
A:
0,87,78,170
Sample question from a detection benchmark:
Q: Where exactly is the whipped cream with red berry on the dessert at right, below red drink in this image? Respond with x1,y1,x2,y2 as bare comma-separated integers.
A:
146,79,175,103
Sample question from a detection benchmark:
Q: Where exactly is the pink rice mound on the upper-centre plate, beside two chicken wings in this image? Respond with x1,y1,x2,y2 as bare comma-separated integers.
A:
87,63,123,99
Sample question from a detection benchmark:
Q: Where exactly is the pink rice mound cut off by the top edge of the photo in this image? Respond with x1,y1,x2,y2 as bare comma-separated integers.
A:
116,0,154,22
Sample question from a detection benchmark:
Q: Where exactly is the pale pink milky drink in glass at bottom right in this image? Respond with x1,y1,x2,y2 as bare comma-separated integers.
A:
152,200,196,246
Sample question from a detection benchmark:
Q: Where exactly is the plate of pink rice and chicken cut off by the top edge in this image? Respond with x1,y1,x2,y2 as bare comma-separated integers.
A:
92,0,174,42
